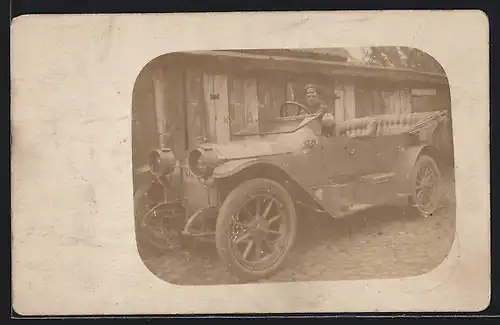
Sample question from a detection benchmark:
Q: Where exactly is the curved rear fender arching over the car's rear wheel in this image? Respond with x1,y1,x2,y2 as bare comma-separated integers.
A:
394,144,438,193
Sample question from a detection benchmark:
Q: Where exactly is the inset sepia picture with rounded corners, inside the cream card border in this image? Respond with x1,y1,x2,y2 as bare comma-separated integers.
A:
132,46,455,285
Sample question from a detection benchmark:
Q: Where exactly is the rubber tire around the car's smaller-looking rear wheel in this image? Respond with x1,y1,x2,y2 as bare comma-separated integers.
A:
409,154,441,217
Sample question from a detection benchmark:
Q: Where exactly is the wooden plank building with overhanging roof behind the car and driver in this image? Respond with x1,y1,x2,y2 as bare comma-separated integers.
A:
133,50,450,182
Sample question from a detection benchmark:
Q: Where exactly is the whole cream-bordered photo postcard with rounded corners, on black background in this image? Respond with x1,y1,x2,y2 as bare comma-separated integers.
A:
11,10,491,317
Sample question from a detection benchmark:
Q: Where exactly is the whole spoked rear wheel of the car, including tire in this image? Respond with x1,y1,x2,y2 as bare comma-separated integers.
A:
410,155,441,217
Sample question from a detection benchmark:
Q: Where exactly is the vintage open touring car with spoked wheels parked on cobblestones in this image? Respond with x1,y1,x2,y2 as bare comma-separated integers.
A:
137,101,449,281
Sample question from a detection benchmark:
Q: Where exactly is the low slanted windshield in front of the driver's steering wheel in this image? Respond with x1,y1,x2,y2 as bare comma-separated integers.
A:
235,114,319,136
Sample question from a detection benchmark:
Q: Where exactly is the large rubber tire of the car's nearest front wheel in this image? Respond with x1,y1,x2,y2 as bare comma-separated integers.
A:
215,178,297,281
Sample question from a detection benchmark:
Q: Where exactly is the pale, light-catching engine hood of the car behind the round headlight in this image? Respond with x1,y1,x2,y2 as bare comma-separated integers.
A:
199,127,316,160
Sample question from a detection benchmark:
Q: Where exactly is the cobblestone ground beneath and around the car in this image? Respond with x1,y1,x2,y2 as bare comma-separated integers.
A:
139,167,455,285
